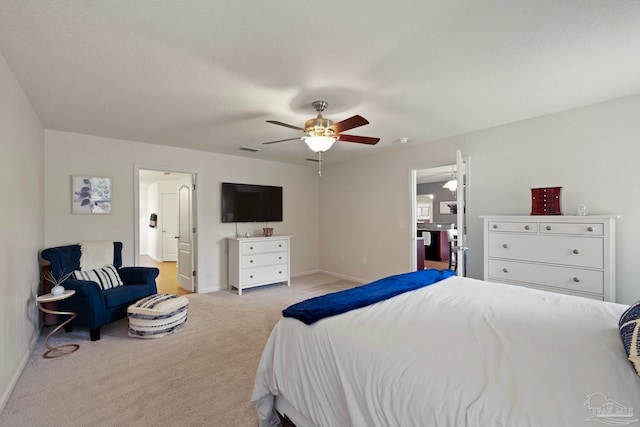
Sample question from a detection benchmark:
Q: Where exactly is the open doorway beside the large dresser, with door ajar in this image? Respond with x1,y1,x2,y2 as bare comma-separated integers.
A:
410,152,468,276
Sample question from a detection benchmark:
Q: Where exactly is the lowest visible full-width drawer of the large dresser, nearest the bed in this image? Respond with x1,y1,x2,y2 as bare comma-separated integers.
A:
489,260,604,294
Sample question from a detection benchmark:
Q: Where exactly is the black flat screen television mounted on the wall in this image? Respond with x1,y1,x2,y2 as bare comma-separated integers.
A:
221,182,282,222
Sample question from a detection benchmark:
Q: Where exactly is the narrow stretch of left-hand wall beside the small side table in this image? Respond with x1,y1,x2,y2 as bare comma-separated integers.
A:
0,54,44,412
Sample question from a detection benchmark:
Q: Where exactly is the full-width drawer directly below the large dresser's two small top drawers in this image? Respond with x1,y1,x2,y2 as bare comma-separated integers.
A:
488,233,604,268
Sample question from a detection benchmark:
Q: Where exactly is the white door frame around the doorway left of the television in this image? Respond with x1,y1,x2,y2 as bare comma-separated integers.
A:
133,164,200,293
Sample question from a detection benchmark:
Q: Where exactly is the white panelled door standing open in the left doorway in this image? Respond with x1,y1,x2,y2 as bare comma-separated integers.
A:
178,185,195,292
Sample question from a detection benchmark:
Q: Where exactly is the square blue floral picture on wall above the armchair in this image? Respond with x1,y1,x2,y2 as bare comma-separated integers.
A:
71,176,111,214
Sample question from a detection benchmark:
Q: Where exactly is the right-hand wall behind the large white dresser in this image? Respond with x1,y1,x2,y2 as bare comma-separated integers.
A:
320,95,640,303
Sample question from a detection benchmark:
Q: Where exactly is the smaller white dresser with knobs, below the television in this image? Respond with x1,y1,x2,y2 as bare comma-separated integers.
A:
228,236,291,295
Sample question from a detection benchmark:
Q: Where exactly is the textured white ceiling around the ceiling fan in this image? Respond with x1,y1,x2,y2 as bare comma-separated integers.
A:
0,0,640,167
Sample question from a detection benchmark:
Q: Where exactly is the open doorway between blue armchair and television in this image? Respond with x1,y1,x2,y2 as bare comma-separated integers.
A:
135,167,197,295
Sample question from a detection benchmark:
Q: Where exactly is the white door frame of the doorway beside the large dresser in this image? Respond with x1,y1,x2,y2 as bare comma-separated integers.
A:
408,153,470,274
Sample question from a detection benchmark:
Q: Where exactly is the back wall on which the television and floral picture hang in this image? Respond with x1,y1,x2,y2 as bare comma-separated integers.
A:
45,130,319,292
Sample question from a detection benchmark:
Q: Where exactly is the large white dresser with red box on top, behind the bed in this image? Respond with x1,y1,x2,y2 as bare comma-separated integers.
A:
482,215,616,301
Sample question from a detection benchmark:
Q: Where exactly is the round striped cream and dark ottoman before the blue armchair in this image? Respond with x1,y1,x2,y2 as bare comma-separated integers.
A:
127,294,189,338
